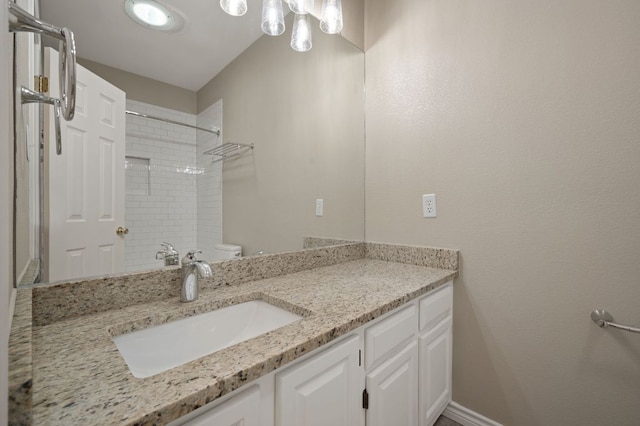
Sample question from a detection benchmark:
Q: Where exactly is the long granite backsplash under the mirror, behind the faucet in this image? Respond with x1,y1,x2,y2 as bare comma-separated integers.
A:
33,243,365,325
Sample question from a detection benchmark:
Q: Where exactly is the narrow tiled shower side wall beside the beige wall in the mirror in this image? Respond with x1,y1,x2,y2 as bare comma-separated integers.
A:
196,100,222,260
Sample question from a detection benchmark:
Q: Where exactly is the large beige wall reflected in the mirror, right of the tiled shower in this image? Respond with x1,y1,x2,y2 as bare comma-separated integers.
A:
198,18,364,254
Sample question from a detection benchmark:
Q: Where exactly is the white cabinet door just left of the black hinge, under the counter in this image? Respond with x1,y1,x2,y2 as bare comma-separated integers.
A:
276,336,362,426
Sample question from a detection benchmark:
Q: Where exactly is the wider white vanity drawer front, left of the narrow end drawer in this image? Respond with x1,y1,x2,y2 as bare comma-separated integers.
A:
364,304,418,369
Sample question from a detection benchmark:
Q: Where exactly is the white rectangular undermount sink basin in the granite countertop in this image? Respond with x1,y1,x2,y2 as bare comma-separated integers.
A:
113,300,302,378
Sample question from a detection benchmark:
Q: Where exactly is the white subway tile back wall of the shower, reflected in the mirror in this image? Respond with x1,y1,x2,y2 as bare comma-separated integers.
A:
125,100,222,271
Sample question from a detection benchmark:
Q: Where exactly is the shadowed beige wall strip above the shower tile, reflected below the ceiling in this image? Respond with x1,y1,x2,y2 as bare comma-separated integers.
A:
78,58,196,114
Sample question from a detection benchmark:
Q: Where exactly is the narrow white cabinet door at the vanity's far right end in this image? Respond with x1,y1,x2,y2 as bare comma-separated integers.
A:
419,316,452,426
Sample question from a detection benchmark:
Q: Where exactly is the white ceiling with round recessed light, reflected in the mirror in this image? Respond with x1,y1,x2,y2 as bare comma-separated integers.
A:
40,0,268,91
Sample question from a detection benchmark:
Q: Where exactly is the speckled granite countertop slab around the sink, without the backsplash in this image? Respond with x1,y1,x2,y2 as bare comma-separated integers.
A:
32,258,457,425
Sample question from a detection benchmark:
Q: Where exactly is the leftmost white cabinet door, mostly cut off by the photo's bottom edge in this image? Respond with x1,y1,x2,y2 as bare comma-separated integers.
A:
185,386,262,426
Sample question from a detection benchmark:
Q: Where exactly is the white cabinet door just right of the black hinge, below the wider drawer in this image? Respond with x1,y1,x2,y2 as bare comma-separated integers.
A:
367,341,418,426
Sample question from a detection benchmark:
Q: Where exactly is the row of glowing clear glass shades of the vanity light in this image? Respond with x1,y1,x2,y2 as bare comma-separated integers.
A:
221,0,343,52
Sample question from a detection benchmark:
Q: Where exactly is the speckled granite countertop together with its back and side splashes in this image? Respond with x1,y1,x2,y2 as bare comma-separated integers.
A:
10,243,458,425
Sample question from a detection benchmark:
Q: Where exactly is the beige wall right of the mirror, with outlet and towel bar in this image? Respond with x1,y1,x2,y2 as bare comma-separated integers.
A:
365,0,640,426
